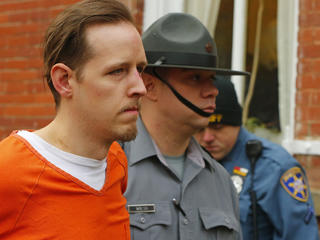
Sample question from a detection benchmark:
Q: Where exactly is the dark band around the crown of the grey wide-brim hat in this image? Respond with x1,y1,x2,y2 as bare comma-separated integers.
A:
146,51,217,68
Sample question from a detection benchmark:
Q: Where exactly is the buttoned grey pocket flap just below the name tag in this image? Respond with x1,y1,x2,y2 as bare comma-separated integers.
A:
130,203,172,230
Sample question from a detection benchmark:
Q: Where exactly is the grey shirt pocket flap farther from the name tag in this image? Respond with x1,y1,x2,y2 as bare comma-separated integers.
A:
199,207,240,232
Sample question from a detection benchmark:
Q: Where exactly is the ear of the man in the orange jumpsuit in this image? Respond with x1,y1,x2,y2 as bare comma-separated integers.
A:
51,63,73,98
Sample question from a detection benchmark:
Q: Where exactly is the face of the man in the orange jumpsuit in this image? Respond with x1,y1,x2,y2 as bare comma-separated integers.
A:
70,22,146,141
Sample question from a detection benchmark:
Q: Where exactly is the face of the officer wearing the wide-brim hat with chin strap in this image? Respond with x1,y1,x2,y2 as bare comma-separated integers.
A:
159,68,218,130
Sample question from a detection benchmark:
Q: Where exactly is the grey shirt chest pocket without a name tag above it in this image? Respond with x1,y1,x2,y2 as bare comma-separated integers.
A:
199,207,241,240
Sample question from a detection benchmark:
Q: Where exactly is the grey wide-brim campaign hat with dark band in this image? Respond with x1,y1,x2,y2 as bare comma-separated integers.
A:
142,13,250,75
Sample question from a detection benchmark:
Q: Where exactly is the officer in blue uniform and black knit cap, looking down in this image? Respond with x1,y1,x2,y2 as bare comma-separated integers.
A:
197,79,319,240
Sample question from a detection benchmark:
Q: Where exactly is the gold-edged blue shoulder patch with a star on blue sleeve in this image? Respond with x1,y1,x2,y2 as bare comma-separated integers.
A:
280,167,309,202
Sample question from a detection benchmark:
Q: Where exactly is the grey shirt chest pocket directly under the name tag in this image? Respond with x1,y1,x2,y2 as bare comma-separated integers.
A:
130,203,172,240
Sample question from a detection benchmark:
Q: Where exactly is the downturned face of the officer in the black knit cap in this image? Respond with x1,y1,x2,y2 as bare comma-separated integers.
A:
196,124,240,161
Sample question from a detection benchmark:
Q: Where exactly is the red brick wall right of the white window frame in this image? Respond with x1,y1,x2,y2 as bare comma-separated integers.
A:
295,0,320,225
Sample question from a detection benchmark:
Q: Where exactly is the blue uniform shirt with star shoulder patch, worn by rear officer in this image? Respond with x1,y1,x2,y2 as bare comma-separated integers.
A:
221,128,319,240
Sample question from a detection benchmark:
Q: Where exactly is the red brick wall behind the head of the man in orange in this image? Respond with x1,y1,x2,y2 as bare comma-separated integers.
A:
0,0,144,140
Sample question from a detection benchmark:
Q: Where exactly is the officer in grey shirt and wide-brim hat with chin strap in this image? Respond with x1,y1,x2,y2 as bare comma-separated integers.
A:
123,13,248,240
